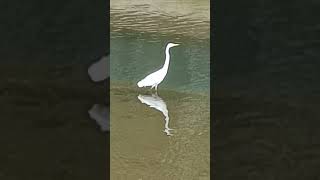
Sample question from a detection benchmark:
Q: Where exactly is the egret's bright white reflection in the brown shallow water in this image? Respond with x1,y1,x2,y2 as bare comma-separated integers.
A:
138,94,173,136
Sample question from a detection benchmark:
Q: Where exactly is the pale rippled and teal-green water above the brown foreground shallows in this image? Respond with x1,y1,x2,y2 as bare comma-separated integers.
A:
110,0,210,93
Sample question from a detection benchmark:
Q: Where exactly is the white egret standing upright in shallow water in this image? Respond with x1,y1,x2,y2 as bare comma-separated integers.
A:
137,43,179,91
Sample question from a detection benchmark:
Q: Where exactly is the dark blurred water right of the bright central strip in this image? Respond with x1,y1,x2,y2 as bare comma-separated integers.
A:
212,0,320,180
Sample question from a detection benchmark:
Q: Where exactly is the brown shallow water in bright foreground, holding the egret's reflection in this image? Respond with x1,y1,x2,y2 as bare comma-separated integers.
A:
110,84,210,179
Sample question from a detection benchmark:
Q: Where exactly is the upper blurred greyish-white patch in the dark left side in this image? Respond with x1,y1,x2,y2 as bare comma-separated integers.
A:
88,56,110,82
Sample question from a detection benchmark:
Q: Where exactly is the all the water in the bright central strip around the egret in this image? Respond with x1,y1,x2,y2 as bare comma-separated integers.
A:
110,0,210,179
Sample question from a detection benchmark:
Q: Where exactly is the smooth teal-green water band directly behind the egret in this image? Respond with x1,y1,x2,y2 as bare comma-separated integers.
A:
111,34,210,92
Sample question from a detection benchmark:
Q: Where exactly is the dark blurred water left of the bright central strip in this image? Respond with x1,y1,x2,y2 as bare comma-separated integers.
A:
0,0,109,180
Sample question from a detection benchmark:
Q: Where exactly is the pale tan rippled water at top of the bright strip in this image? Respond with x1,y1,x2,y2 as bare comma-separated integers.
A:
110,0,210,42
